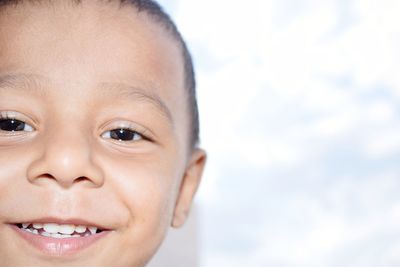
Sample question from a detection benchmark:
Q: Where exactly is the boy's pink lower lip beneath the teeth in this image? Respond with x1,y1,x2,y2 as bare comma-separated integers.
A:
12,225,110,256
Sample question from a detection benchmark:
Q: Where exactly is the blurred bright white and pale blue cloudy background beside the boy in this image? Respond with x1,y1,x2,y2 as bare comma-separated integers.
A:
149,0,400,267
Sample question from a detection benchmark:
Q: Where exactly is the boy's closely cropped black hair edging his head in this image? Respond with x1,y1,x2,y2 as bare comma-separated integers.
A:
0,0,200,148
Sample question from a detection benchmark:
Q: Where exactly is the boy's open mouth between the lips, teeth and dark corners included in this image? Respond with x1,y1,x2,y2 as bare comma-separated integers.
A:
16,223,103,238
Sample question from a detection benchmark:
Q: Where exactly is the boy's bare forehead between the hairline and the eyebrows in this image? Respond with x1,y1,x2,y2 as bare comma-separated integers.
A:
0,1,188,142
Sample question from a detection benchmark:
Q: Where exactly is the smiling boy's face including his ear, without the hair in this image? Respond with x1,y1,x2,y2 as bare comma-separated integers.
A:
0,1,205,267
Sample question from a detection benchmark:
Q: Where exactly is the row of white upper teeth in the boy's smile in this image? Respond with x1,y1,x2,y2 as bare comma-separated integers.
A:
22,223,97,237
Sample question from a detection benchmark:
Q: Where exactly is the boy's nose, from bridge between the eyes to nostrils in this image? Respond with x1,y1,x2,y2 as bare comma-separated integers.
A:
27,125,104,188
